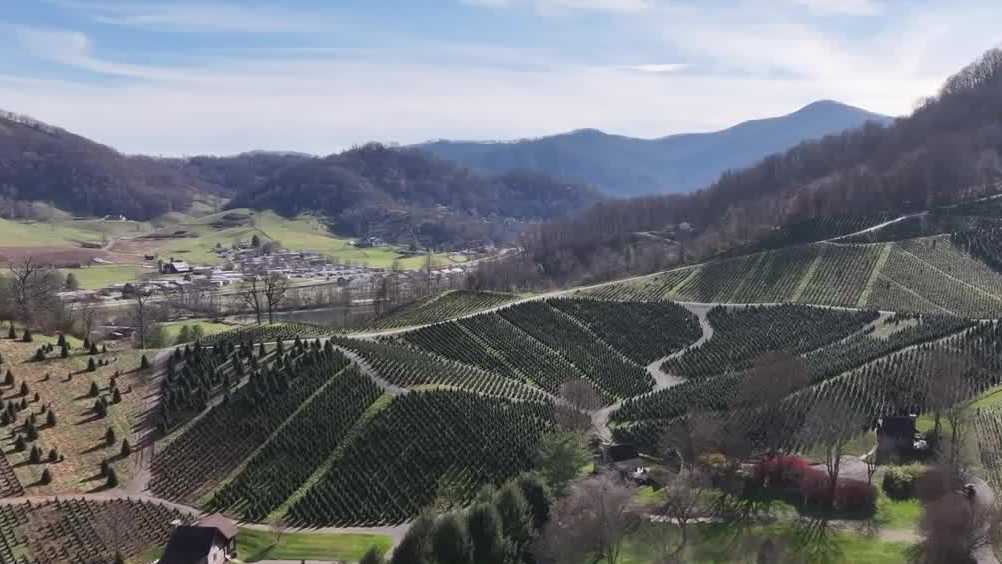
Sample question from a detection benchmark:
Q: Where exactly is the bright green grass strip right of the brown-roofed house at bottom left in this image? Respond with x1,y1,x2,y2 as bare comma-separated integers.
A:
236,528,393,562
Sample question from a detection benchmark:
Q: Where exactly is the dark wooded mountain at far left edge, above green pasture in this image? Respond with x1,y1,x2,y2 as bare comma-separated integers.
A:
0,112,213,219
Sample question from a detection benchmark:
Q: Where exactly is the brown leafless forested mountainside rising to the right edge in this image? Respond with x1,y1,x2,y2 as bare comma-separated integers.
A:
496,49,1002,285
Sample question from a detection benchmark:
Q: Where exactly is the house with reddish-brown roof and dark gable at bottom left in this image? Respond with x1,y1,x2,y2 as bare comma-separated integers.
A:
157,513,236,564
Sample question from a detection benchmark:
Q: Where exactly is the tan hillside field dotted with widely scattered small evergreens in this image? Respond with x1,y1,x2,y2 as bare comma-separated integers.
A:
0,332,149,495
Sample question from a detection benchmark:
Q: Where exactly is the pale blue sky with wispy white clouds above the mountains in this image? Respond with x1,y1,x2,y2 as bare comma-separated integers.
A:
0,0,1002,155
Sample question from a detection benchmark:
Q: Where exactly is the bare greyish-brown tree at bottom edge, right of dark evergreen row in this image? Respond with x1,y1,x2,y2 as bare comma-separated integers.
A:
534,475,640,564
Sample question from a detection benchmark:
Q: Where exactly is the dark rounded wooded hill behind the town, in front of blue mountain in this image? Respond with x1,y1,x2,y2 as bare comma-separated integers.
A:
230,143,600,246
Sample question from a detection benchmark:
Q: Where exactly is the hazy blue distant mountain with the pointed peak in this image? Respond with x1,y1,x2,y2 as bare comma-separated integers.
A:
416,100,890,196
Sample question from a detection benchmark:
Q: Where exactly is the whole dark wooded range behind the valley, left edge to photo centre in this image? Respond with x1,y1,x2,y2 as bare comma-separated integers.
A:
0,112,601,247
